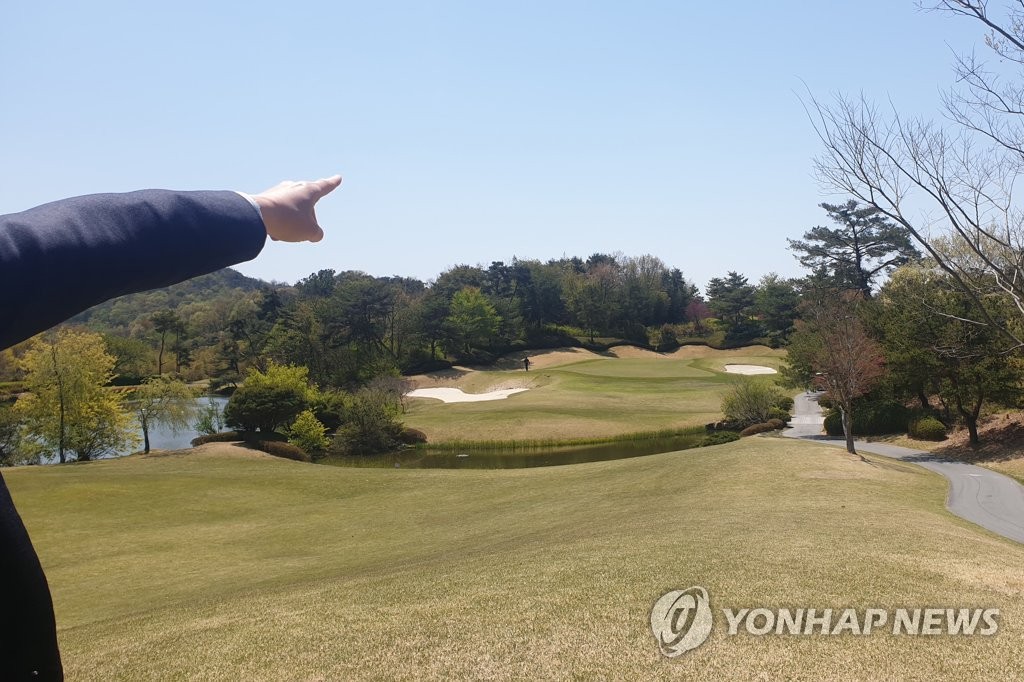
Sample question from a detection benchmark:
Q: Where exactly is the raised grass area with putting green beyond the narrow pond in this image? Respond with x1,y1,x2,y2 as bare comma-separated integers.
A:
403,346,784,442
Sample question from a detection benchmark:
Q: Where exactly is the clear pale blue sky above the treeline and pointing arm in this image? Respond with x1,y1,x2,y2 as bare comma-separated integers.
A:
0,0,982,287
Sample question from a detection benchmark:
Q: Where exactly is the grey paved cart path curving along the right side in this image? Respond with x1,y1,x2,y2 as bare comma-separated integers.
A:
783,393,1024,543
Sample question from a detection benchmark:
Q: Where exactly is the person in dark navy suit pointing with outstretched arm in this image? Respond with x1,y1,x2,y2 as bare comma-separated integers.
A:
0,175,341,682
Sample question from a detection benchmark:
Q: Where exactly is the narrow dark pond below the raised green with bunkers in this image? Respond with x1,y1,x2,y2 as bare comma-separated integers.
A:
321,433,703,469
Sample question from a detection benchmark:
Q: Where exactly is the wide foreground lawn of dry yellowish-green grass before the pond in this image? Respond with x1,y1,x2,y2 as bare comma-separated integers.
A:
5,437,1024,680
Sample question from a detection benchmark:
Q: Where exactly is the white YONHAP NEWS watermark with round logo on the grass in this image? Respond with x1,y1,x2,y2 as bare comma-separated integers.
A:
650,586,999,658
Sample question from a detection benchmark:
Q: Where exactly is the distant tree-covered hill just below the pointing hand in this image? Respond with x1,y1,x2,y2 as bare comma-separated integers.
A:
69,267,280,332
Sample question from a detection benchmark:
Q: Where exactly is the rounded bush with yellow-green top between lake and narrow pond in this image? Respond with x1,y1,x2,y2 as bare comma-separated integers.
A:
224,363,311,433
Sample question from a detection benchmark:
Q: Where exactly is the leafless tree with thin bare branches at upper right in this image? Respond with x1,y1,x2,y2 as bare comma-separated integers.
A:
807,0,1024,347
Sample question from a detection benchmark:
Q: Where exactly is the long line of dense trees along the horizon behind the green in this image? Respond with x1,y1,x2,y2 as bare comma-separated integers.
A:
0,253,799,387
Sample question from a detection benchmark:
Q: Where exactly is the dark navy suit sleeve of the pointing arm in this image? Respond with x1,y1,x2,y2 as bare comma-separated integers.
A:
0,189,266,349
